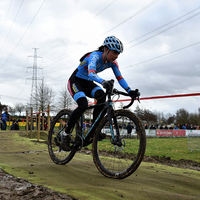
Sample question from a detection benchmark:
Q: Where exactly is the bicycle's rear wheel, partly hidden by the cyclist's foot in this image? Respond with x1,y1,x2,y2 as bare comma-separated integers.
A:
48,109,76,165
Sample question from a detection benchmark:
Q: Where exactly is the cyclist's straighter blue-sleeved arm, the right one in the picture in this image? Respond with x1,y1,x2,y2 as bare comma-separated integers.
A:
112,61,131,92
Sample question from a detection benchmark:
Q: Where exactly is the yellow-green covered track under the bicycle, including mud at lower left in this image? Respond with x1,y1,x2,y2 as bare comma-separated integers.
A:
0,132,200,200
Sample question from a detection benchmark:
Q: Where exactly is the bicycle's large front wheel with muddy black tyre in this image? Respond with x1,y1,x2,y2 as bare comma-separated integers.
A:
92,110,146,179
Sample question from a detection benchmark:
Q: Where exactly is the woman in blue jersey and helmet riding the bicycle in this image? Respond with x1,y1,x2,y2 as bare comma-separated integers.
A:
61,36,137,151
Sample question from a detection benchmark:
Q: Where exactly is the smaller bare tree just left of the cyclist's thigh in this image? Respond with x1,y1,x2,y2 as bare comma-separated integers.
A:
58,85,74,109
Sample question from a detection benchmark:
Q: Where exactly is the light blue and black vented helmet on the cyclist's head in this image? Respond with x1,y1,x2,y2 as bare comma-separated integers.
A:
103,36,123,53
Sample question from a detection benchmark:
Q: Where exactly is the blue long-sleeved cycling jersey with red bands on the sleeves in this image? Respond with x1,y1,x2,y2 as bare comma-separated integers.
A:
76,51,131,92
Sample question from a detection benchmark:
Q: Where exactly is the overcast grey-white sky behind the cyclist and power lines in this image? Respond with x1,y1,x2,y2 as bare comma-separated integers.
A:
0,0,200,115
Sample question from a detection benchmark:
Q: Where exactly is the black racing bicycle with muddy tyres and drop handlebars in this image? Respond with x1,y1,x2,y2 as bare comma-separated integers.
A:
48,81,146,179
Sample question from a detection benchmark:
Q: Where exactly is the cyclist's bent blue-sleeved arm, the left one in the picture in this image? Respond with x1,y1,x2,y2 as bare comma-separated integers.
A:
88,53,103,83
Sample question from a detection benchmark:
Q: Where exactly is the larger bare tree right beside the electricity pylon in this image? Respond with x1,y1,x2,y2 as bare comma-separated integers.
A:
32,81,55,111
